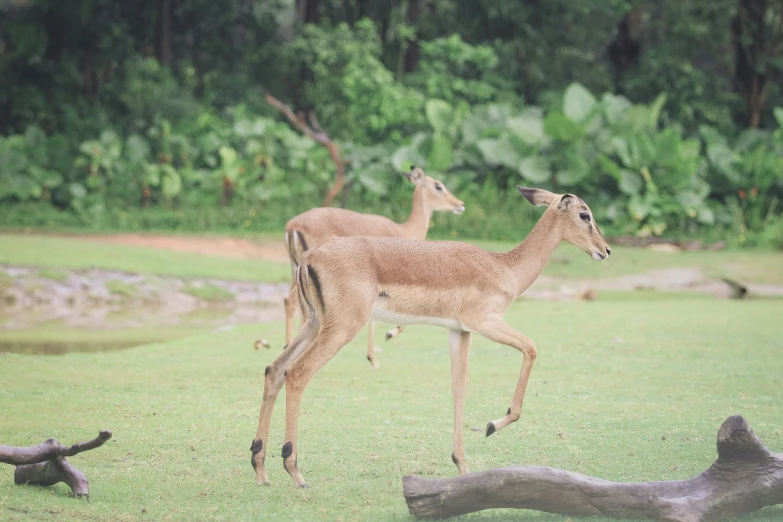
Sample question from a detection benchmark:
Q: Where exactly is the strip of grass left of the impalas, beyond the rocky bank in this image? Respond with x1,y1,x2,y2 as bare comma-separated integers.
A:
0,234,291,282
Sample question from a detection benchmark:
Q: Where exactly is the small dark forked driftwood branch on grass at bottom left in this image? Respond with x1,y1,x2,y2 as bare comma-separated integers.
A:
0,431,111,498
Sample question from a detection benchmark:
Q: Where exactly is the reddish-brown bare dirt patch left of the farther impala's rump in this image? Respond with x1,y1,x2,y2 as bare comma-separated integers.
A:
68,234,288,262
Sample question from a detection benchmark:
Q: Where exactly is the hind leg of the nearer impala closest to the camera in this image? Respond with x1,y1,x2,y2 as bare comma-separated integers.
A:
283,316,372,488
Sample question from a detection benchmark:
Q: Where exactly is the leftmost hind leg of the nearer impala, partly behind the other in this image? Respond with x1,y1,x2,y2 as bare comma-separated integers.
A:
250,319,318,485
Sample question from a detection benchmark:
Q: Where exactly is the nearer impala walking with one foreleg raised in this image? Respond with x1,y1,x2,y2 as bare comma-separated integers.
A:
250,187,610,487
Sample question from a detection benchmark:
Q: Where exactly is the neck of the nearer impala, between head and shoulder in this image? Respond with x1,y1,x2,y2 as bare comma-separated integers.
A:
502,211,562,295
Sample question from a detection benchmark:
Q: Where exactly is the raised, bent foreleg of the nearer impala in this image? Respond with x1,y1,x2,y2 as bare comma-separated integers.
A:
471,314,536,437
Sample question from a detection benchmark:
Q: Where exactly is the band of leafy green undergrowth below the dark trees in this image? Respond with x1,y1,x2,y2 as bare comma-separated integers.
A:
0,80,783,242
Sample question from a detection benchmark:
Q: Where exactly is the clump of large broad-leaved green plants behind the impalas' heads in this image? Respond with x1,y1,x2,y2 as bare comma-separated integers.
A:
393,84,748,236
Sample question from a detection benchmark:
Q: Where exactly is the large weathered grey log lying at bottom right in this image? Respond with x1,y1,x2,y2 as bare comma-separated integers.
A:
402,415,783,522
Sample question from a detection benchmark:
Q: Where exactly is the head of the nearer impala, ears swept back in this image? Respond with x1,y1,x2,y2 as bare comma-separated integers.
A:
517,186,612,261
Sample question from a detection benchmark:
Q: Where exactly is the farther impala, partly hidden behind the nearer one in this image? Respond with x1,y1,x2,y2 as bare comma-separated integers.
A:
285,167,465,369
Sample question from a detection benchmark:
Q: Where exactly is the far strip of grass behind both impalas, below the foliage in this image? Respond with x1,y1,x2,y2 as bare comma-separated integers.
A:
0,234,783,284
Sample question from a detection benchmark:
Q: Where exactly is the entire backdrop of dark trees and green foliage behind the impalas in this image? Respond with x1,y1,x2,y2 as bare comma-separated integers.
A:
0,0,783,246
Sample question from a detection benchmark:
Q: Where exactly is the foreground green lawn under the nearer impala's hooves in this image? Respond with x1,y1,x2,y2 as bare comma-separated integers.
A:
0,296,783,521
